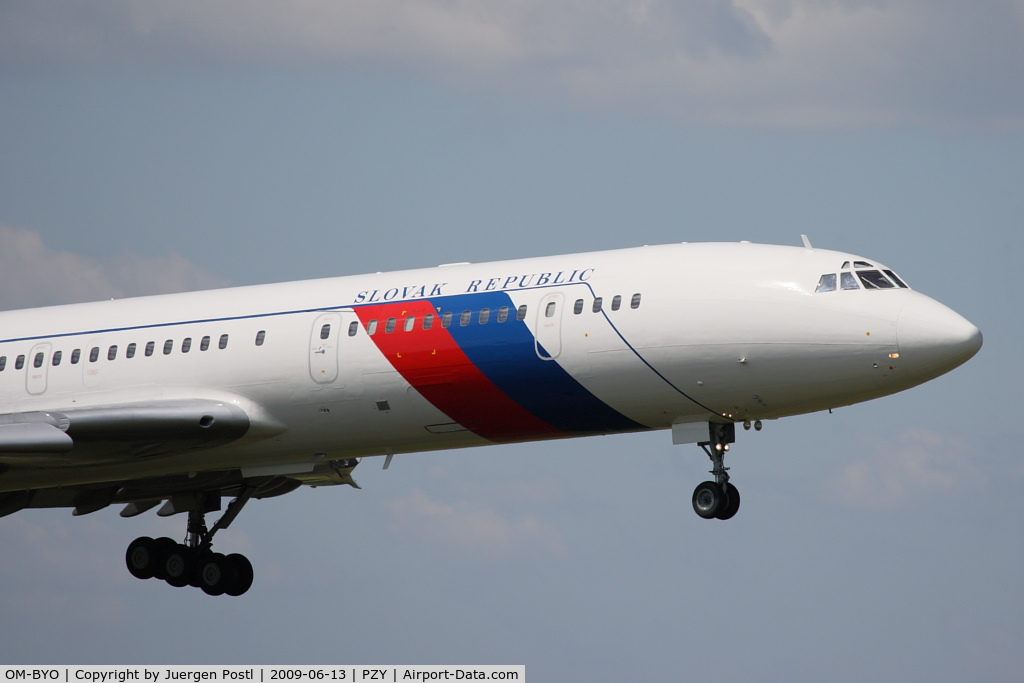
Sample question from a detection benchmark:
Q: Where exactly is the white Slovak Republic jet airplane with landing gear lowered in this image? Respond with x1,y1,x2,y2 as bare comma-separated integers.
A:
0,237,982,596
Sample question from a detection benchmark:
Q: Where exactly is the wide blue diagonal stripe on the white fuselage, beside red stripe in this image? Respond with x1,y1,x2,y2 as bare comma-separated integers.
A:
430,292,646,434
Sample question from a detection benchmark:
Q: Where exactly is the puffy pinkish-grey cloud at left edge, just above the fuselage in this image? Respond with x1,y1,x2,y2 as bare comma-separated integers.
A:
0,224,227,310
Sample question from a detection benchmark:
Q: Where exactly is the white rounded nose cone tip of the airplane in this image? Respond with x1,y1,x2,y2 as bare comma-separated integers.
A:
896,292,982,381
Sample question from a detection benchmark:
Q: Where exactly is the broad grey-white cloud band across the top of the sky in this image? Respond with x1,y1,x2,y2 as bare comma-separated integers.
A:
0,0,1024,128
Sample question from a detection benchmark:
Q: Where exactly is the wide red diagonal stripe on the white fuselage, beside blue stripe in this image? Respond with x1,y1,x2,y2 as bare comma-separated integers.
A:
355,300,563,441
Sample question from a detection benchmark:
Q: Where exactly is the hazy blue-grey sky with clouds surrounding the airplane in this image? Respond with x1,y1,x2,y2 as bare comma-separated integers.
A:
0,0,1024,683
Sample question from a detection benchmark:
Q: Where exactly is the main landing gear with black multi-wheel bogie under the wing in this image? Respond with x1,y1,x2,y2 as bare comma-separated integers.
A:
125,489,254,595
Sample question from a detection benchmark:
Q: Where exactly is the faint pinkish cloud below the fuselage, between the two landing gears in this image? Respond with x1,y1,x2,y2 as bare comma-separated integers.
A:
385,488,566,560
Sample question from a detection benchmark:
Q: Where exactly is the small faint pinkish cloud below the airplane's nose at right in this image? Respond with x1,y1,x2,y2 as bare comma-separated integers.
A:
822,428,987,510
